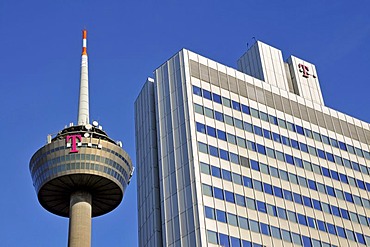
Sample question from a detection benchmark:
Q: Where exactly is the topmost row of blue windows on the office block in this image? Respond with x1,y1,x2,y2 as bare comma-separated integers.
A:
193,86,370,160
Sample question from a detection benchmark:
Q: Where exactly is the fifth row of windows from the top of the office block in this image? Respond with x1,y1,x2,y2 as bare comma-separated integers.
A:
200,163,370,227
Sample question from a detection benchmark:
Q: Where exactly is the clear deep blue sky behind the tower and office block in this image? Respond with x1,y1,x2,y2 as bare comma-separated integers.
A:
0,0,370,247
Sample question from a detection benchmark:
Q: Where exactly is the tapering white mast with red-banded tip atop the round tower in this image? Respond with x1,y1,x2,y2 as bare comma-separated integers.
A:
77,29,89,125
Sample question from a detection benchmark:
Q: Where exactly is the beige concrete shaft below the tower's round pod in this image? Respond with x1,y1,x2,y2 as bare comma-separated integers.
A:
68,191,91,247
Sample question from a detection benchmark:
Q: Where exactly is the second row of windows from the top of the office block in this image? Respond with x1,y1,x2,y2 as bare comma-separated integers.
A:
194,104,370,179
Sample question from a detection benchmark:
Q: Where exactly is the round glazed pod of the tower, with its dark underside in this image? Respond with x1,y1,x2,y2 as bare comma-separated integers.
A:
30,128,133,217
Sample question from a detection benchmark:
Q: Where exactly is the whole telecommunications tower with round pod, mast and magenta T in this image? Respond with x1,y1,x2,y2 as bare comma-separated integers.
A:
29,30,133,247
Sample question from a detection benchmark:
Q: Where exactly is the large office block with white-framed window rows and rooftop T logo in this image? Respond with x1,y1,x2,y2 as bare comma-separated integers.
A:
135,41,370,247
